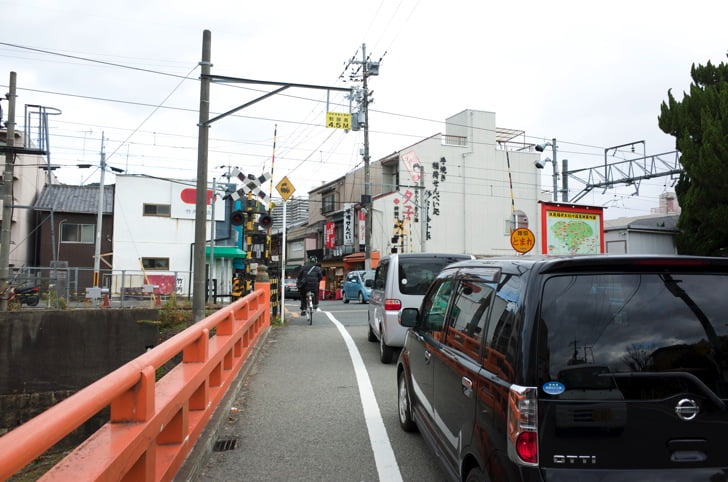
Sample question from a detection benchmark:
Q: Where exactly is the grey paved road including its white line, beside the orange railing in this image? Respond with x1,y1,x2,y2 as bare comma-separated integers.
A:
183,301,445,481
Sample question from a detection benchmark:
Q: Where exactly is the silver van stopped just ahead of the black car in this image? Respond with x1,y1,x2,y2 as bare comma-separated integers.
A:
367,253,474,363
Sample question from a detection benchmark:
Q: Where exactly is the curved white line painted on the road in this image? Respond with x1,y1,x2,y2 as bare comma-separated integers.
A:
325,311,402,482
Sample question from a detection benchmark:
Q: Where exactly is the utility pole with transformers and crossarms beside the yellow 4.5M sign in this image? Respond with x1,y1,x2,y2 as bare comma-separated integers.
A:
346,44,381,269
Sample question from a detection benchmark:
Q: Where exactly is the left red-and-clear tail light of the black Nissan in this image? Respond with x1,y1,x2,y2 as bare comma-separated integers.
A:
508,385,538,465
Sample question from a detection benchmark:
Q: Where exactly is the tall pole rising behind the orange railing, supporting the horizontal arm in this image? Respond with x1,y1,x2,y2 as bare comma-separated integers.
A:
192,30,212,321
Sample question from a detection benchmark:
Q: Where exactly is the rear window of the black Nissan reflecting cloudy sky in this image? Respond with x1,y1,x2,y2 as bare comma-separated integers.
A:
538,273,728,400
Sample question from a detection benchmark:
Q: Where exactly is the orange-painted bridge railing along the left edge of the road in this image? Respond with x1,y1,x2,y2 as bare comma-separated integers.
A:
0,282,270,482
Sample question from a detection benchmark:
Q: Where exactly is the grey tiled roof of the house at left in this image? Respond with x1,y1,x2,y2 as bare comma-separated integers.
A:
33,184,114,214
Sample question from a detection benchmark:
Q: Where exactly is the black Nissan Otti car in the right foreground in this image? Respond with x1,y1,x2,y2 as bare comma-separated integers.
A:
397,255,728,481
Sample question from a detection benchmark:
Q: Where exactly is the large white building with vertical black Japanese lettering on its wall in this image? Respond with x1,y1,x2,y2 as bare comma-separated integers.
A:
372,110,541,255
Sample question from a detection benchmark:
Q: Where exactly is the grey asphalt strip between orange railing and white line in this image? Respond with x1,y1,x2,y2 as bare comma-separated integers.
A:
185,305,379,481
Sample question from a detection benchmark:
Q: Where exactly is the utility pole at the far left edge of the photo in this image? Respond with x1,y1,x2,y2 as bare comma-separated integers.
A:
0,72,17,311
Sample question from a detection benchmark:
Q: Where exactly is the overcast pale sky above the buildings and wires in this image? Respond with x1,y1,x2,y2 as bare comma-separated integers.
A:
0,0,728,219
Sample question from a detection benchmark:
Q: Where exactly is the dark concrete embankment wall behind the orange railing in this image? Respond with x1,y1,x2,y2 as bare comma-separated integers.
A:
0,309,160,434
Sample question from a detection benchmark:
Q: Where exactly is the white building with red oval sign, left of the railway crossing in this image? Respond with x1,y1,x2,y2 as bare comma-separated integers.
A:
114,175,245,294
